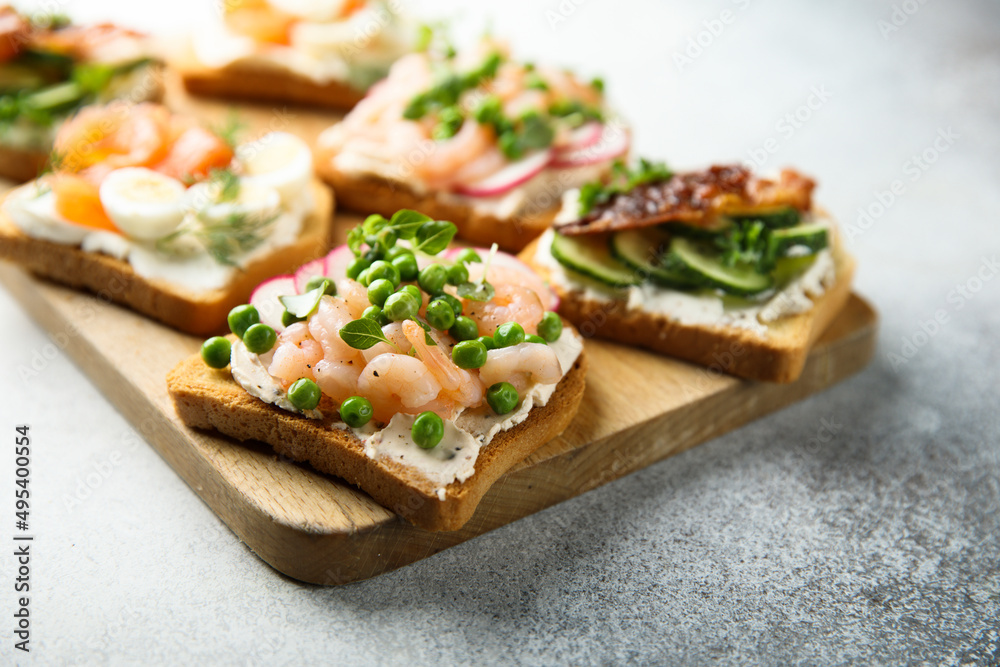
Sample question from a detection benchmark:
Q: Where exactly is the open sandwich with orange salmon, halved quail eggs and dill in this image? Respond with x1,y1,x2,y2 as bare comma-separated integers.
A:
0,103,332,334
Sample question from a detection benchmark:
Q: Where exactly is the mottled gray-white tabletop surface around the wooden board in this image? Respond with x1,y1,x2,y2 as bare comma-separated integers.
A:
0,0,1000,665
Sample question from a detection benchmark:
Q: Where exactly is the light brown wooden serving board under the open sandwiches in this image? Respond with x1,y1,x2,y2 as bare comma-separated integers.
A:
0,264,877,584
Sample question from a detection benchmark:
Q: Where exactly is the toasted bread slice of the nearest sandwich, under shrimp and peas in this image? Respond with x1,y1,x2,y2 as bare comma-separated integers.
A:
167,344,587,531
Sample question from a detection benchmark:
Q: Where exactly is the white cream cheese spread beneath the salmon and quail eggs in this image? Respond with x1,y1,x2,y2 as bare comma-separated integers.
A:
3,182,315,292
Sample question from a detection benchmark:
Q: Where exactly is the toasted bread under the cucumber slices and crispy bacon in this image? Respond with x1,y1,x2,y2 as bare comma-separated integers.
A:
520,237,855,382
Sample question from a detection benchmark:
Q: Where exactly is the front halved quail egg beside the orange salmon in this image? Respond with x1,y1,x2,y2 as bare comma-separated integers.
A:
100,167,186,241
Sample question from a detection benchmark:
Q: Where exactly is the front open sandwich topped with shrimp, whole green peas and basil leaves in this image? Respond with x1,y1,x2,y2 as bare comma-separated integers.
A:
167,210,586,530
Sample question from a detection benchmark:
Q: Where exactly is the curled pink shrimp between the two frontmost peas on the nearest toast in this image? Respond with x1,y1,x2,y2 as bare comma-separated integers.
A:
358,354,455,423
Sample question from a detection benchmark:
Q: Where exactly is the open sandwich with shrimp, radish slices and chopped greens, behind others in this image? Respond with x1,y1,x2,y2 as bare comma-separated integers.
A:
316,39,629,250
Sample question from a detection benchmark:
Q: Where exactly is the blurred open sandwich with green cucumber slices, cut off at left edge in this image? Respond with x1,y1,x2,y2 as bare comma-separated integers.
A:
0,6,163,182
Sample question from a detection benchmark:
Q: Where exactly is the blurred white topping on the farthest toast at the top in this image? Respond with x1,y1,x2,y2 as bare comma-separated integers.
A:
191,3,413,90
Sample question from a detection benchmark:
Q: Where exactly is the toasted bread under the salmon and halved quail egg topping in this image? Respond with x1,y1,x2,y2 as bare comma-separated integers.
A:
0,182,333,335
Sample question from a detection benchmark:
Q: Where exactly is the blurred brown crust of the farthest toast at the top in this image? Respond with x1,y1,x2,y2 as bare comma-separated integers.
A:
176,55,366,109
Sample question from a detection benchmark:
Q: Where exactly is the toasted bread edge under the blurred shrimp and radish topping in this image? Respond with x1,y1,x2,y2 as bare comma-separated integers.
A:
316,151,559,252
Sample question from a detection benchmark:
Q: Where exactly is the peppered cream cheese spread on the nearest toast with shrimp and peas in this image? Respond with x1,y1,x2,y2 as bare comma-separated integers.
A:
231,327,583,500
